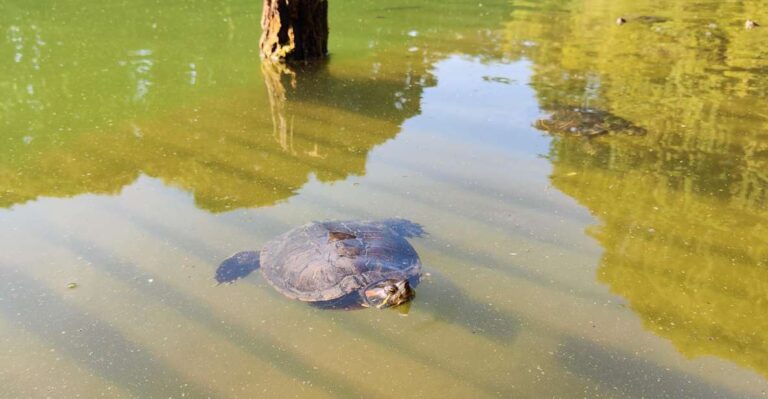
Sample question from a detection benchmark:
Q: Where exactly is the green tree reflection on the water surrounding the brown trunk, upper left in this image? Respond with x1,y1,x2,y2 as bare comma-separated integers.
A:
0,1,510,212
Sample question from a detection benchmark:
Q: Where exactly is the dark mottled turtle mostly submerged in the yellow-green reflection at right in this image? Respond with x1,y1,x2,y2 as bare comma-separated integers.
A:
533,106,646,138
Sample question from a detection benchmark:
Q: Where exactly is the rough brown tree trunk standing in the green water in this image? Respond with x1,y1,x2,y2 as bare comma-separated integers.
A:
260,0,328,61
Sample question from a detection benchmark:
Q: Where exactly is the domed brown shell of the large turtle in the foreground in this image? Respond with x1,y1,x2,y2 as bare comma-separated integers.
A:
260,219,423,302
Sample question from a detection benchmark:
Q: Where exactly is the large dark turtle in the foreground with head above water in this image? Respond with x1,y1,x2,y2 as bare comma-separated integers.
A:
215,219,424,309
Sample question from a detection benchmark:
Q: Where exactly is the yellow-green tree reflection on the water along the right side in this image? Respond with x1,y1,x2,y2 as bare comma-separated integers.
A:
507,1,768,376
